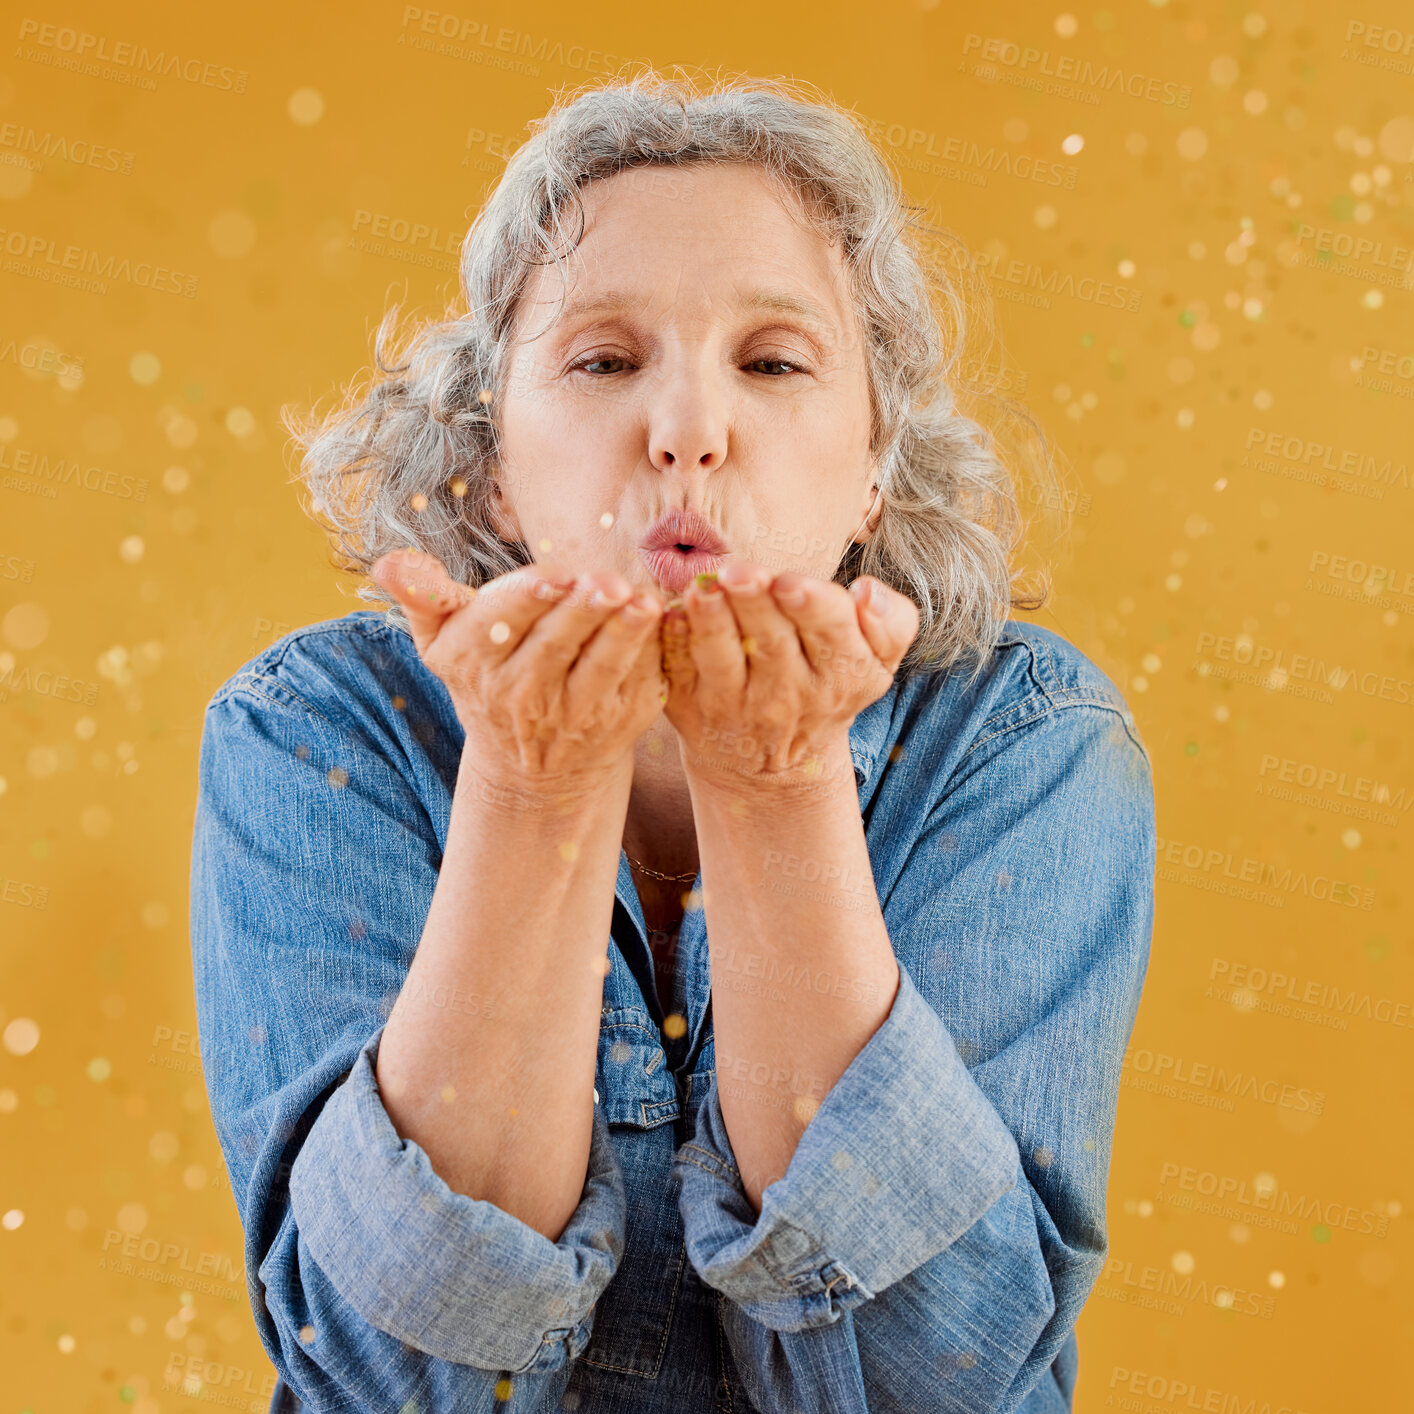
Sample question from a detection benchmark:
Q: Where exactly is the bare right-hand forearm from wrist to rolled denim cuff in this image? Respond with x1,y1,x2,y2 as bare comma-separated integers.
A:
690,747,898,1212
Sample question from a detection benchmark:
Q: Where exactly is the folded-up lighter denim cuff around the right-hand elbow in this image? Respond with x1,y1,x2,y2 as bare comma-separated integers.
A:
677,969,1021,1331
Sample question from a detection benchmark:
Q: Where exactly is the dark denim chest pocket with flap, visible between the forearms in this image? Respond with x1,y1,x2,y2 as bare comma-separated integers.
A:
580,1007,687,1379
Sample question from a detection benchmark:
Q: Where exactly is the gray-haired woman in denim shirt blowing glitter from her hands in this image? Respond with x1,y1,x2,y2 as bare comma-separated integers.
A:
192,75,1154,1414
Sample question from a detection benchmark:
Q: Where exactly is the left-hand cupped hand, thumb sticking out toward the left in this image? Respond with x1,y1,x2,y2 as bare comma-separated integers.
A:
372,550,665,793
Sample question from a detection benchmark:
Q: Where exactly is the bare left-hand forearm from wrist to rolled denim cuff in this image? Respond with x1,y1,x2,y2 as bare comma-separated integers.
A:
378,758,631,1241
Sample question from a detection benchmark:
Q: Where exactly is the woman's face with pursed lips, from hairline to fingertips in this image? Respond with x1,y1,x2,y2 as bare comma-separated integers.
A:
498,164,875,597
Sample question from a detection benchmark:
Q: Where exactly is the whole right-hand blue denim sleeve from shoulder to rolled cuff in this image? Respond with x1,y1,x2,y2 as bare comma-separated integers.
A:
674,694,1154,1414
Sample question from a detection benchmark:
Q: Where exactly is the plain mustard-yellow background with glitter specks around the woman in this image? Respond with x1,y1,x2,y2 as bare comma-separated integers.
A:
0,0,1414,1414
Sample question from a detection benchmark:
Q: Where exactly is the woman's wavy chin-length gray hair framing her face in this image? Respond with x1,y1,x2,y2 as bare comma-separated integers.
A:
281,69,1053,676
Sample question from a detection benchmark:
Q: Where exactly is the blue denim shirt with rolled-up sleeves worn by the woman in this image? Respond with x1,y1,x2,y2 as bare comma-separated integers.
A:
191,609,1155,1414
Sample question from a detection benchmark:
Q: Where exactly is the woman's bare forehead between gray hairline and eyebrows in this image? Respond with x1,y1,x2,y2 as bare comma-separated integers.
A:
514,163,855,332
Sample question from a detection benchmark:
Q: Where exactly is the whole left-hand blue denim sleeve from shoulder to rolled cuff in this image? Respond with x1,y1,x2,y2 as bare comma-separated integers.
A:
191,660,626,1414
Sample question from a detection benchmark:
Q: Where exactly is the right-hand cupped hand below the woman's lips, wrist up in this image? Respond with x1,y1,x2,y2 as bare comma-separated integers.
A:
663,560,921,790
